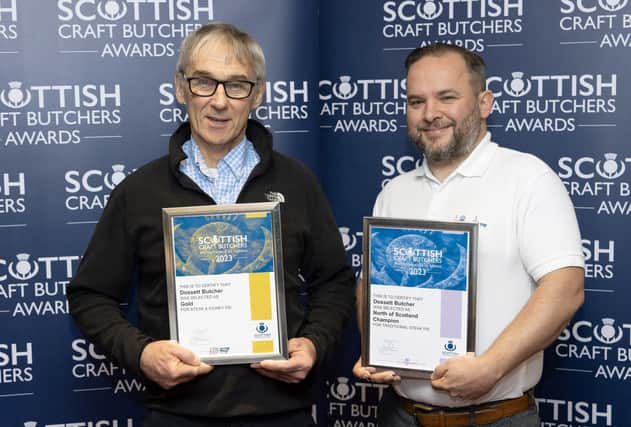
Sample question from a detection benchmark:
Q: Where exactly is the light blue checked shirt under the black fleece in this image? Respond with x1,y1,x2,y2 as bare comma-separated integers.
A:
180,138,261,205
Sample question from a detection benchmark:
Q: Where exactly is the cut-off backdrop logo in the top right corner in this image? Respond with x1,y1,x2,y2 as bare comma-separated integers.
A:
559,0,631,49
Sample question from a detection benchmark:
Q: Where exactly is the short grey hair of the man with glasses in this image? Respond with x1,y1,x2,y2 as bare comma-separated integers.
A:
176,22,265,82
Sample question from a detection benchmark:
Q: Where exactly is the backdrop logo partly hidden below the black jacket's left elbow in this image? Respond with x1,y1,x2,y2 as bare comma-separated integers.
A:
70,338,145,395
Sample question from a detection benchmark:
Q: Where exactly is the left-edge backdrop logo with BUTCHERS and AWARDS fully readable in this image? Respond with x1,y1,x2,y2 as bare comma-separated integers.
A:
0,80,121,147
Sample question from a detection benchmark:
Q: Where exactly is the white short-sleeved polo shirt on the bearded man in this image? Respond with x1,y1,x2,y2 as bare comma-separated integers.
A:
373,133,584,407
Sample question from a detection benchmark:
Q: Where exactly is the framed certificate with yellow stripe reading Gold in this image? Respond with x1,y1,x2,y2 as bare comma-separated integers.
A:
162,203,287,365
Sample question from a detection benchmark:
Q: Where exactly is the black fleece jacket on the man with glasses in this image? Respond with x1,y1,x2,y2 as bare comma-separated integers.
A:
67,120,354,417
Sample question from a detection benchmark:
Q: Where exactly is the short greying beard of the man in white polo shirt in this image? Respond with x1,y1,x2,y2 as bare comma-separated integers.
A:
408,106,482,163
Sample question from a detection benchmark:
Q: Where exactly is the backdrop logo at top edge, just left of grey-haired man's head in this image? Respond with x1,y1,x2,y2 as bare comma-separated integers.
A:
56,0,214,58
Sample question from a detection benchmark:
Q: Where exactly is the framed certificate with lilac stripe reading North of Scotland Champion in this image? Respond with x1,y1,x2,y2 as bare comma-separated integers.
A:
361,217,478,378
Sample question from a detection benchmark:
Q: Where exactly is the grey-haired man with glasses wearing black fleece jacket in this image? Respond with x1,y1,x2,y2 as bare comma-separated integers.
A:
68,23,354,427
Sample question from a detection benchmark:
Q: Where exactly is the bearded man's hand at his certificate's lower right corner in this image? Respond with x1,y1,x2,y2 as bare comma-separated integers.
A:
431,353,499,400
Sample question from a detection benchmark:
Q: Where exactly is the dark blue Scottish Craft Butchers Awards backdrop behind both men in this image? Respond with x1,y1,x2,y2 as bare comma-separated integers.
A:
0,0,631,427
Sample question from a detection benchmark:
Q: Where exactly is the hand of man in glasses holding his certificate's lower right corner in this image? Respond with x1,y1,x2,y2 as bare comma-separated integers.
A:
250,338,316,384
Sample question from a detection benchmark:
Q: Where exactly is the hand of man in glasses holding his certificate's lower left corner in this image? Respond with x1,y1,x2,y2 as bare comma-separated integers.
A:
140,340,213,390
